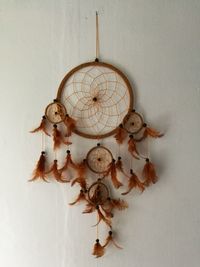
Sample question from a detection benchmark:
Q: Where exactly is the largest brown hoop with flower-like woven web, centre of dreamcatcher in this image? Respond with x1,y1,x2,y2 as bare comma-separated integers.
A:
57,61,133,139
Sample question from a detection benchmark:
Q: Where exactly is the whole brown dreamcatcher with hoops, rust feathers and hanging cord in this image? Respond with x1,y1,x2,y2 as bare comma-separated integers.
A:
30,14,162,257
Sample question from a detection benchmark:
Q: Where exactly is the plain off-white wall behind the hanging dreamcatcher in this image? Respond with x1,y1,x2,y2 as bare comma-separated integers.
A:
0,0,200,267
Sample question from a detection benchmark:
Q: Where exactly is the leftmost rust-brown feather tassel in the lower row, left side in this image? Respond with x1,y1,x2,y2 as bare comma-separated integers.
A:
29,151,48,182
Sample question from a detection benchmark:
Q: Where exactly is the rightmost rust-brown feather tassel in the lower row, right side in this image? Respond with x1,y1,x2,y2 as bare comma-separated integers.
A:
142,158,158,186
